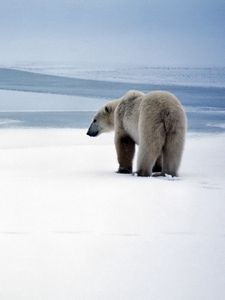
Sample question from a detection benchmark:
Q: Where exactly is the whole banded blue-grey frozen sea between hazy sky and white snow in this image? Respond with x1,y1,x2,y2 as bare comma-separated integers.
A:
0,65,225,133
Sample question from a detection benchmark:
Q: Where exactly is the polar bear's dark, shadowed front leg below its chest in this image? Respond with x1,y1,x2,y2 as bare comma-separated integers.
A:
115,134,135,174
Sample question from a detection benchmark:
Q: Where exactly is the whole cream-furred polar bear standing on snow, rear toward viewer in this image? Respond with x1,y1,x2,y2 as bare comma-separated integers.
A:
87,91,186,176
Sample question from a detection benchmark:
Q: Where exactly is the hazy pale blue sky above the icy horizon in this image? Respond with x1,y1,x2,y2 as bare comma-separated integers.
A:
0,0,225,66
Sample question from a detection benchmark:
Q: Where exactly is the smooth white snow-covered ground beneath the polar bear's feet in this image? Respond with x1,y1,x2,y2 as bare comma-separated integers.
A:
0,129,225,300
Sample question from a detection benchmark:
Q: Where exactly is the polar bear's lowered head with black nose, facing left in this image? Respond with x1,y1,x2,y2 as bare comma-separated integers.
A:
87,102,115,137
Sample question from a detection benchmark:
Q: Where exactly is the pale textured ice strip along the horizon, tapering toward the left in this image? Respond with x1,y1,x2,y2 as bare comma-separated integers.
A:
6,64,225,87
